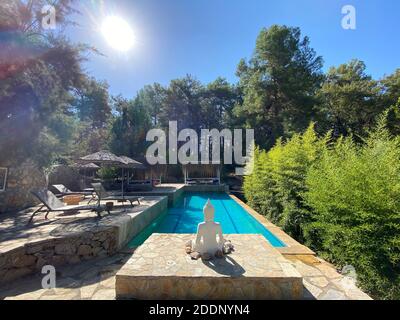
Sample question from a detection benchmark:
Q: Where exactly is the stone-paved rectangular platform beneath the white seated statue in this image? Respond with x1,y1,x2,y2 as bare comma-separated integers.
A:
116,233,303,300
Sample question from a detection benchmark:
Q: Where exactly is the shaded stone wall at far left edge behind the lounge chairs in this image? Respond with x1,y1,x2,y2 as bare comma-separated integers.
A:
0,161,46,214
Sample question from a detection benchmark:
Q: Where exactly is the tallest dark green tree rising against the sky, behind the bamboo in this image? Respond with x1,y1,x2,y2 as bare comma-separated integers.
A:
235,25,323,147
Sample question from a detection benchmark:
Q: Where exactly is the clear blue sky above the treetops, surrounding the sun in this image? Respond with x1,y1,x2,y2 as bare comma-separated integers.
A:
67,0,400,98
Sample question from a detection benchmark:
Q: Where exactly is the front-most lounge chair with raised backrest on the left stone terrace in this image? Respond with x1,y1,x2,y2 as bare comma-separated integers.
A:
28,189,110,224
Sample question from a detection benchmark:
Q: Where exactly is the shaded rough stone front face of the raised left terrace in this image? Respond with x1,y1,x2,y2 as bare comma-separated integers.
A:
0,228,118,284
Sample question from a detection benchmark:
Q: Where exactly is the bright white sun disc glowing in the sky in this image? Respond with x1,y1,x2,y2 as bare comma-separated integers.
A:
101,16,135,52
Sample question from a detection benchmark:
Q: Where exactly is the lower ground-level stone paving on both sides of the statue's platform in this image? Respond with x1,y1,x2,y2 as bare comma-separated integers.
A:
0,236,371,300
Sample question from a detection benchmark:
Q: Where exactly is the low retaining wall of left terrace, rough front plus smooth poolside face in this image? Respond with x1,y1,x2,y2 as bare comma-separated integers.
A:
0,197,168,284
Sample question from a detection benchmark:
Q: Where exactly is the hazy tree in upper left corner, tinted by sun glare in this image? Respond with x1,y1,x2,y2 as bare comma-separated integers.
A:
0,0,84,165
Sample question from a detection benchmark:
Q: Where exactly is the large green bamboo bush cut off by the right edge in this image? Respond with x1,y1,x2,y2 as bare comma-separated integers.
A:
304,118,400,299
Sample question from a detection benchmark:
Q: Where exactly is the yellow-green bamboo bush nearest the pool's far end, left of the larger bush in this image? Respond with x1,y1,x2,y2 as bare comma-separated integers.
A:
244,124,325,241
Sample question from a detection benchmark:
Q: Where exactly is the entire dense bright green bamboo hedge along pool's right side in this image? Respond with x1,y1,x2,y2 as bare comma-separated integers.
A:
244,118,400,299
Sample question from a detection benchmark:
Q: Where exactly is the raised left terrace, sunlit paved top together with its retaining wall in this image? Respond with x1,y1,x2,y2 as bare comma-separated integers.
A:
0,196,168,286
